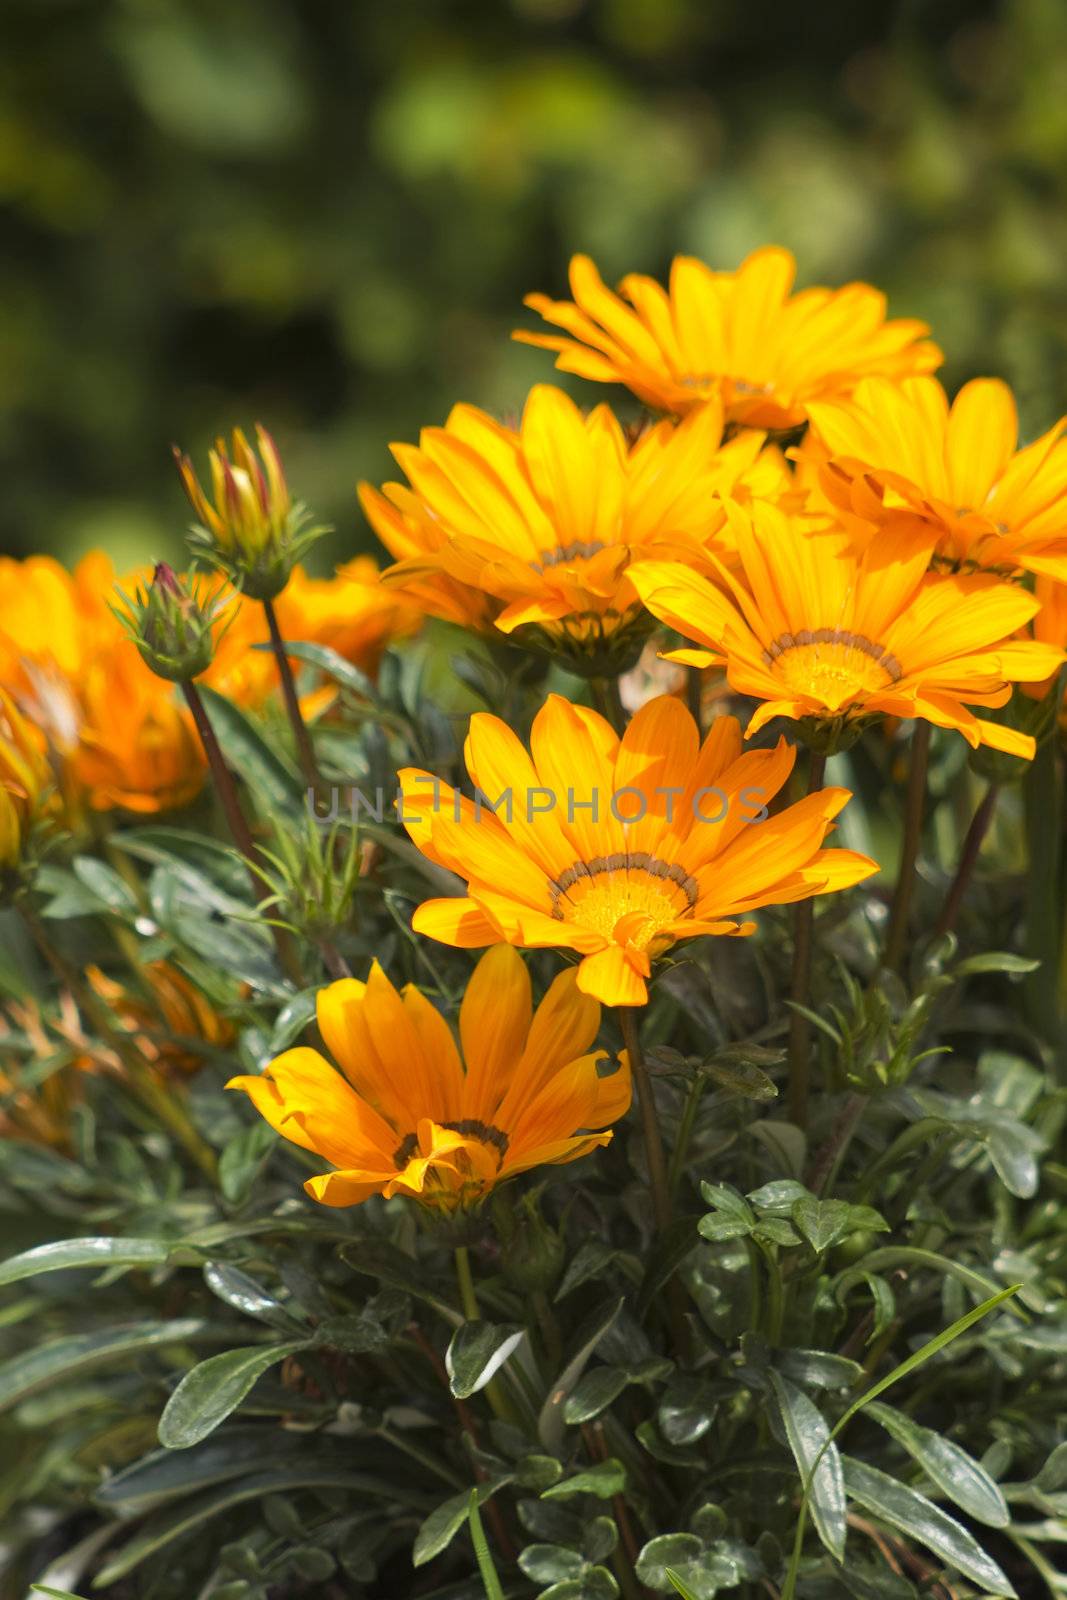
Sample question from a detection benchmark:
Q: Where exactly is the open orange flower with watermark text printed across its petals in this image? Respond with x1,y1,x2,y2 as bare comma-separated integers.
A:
400,694,877,1005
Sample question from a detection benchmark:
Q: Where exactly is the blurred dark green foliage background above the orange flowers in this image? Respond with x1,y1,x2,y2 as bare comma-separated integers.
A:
0,0,1067,576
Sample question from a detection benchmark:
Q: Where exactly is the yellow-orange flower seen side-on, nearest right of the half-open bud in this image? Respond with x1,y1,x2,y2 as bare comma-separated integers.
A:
362,384,787,672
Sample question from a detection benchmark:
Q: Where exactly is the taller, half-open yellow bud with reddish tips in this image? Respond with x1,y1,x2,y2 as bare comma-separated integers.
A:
174,424,326,600
